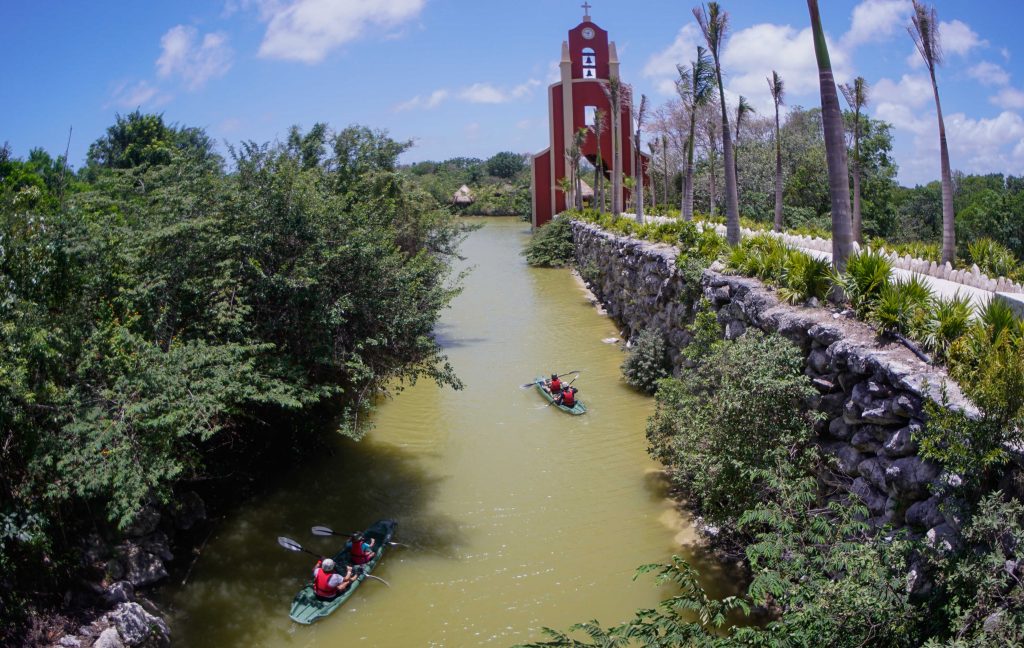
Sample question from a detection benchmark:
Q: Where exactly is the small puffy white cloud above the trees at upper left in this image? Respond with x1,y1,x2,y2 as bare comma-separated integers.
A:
157,25,233,90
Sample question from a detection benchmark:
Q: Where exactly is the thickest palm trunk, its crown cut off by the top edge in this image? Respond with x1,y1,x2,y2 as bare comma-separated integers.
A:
807,0,853,272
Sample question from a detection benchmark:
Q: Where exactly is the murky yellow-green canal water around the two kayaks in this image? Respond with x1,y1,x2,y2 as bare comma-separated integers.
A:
162,218,729,648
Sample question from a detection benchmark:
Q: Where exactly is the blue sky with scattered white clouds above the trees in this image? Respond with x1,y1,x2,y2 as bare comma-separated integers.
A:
0,0,1024,185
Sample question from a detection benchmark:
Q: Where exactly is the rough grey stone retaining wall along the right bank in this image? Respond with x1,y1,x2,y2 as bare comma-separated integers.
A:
572,221,977,539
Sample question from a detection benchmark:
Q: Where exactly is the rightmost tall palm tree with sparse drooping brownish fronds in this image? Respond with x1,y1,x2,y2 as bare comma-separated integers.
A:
907,0,956,264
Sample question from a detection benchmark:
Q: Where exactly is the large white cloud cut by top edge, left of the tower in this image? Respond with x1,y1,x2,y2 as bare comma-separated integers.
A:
259,0,426,63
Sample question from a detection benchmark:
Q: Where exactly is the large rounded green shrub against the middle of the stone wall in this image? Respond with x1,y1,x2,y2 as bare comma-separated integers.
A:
647,331,817,526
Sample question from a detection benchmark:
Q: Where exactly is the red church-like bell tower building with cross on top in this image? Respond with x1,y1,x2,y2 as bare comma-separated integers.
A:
531,4,649,227
